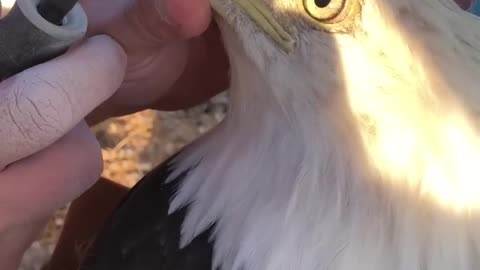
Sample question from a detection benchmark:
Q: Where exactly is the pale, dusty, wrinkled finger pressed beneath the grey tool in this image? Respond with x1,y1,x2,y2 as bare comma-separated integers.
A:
0,34,126,169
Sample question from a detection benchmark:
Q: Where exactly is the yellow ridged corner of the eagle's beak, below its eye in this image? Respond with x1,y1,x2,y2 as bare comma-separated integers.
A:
233,0,295,51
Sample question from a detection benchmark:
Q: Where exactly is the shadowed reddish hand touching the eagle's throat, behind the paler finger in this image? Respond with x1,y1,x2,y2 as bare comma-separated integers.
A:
82,0,228,123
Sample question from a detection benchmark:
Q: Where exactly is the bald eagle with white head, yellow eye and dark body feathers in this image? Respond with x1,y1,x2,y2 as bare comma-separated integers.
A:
81,0,480,270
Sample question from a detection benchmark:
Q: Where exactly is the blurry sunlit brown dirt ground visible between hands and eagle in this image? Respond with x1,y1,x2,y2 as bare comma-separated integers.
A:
20,95,227,270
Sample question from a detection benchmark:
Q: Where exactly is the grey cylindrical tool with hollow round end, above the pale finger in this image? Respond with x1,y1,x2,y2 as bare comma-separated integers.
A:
0,0,88,81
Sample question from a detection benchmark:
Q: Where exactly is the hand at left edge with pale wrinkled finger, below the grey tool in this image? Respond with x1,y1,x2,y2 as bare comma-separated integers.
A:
0,37,126,270
